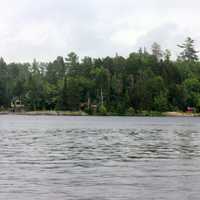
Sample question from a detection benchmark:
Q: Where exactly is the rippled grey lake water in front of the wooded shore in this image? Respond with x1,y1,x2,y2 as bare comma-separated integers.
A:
0,115,200,200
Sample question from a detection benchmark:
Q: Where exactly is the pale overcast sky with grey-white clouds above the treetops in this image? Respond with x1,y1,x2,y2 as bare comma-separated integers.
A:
0,0,200,62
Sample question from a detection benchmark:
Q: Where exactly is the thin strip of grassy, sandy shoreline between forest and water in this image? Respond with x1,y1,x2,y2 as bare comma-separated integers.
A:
0,111,200,117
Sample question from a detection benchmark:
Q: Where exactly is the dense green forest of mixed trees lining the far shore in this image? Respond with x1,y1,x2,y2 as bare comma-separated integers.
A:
0,37,200,115
